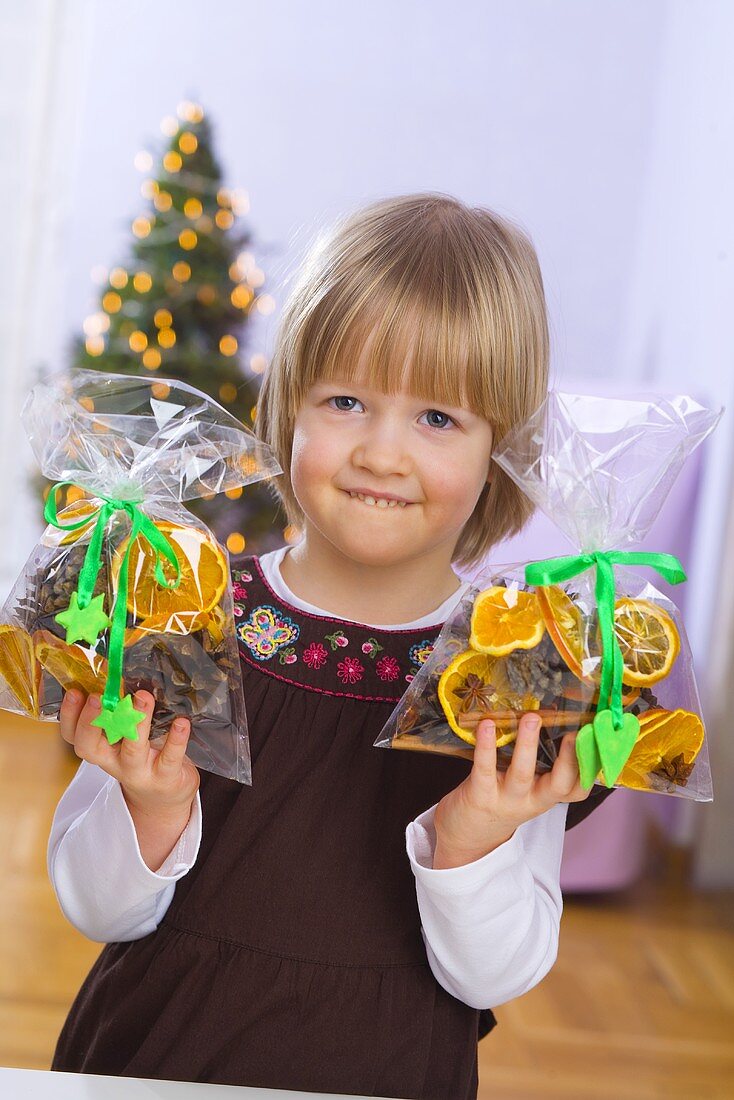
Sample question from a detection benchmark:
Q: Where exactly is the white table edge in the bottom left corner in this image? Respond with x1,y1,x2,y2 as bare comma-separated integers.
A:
0,1066,398,1100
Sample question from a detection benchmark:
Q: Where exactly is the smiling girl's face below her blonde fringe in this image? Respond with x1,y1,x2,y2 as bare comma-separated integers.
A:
291,378,492,565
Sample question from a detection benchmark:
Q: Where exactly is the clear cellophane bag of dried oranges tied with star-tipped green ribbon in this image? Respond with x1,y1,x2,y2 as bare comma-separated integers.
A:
0,370,282,783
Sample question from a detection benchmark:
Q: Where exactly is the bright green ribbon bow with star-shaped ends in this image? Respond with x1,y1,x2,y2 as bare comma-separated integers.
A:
44,482,180,745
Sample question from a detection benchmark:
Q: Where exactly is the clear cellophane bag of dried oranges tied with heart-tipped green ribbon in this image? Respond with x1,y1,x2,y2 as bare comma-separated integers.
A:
375,391,723,801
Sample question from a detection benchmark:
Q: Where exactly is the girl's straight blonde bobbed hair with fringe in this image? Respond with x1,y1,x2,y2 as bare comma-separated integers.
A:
254,193,550,567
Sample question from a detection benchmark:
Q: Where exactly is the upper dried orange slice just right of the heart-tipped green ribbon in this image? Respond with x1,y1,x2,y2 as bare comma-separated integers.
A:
614,596,680,688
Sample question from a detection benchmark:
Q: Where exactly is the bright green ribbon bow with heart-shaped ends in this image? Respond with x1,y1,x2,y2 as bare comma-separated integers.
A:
525,550,686,790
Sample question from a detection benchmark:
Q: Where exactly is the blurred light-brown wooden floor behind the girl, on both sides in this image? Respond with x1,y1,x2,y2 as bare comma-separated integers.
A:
0,713,734,1100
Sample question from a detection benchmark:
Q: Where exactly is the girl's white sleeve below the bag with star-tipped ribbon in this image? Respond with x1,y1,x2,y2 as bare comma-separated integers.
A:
47,760,201,943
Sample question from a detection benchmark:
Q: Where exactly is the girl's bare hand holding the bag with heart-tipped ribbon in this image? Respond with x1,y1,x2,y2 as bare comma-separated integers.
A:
434,713,593,870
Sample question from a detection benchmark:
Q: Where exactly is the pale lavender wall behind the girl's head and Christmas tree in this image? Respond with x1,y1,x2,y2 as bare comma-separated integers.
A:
65,0,666,387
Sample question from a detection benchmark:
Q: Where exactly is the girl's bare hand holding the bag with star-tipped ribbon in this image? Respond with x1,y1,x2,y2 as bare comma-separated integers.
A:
58,690,199,824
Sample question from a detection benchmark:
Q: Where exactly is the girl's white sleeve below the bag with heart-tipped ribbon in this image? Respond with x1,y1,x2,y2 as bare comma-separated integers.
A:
406,803,568,1009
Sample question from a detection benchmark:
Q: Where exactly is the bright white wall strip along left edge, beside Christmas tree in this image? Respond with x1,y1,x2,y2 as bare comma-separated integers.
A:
0,0,88,602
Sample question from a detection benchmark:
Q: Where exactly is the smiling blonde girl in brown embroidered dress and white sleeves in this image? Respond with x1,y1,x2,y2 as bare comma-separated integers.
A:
48,194,609,1100
